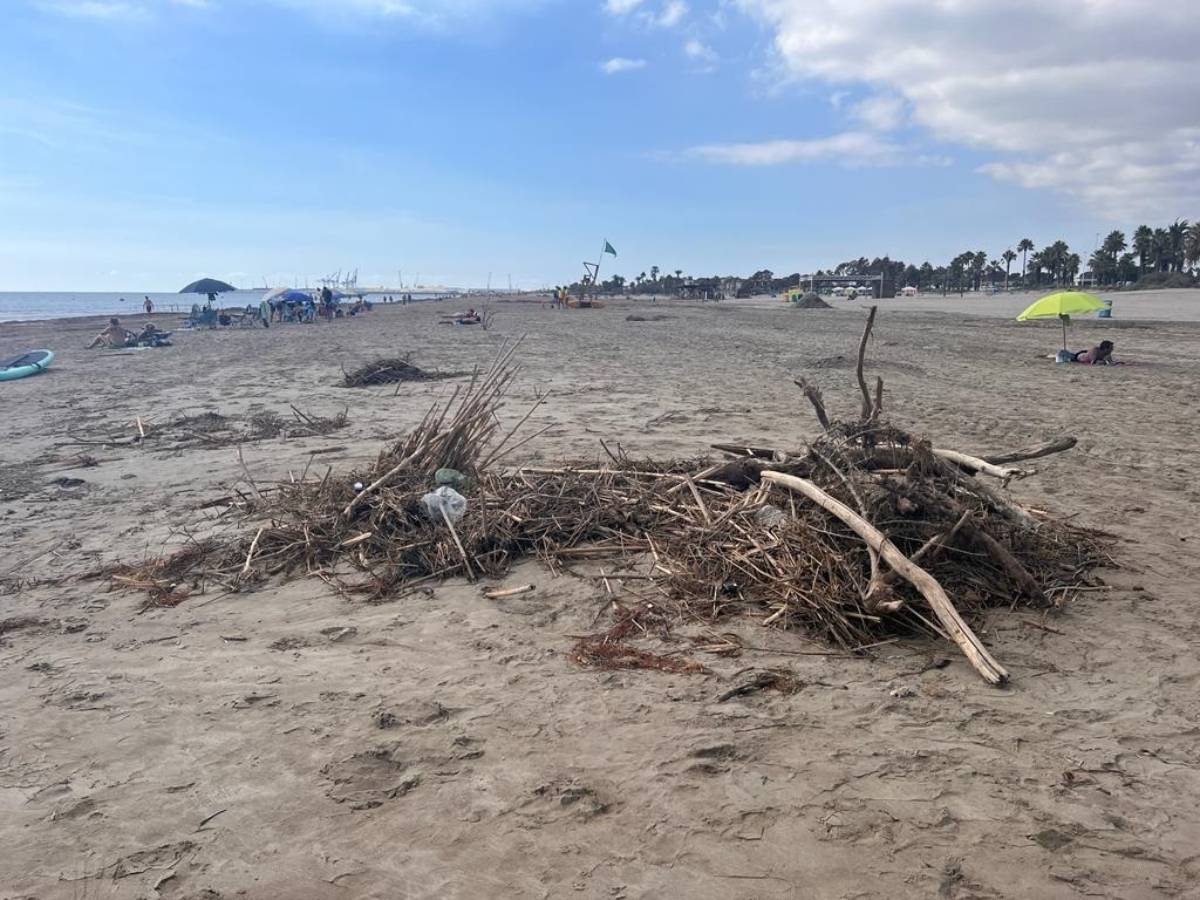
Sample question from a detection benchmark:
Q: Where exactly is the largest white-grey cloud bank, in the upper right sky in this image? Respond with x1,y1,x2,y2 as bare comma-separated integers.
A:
733,0,1200,218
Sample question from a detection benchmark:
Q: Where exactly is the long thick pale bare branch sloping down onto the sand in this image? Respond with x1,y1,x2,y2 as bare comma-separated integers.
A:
762,472,1008,684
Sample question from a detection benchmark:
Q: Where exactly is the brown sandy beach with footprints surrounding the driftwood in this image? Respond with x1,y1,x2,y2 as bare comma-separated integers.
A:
0,290,1200,900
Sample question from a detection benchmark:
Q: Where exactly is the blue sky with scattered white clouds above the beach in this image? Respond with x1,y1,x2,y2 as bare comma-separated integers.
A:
0,0,1200,290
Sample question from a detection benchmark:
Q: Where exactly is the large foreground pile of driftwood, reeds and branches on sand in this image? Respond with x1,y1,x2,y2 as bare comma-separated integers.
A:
118,324,1108,683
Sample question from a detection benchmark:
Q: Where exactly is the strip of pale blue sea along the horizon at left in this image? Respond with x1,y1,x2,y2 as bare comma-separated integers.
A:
0,289,440,323
